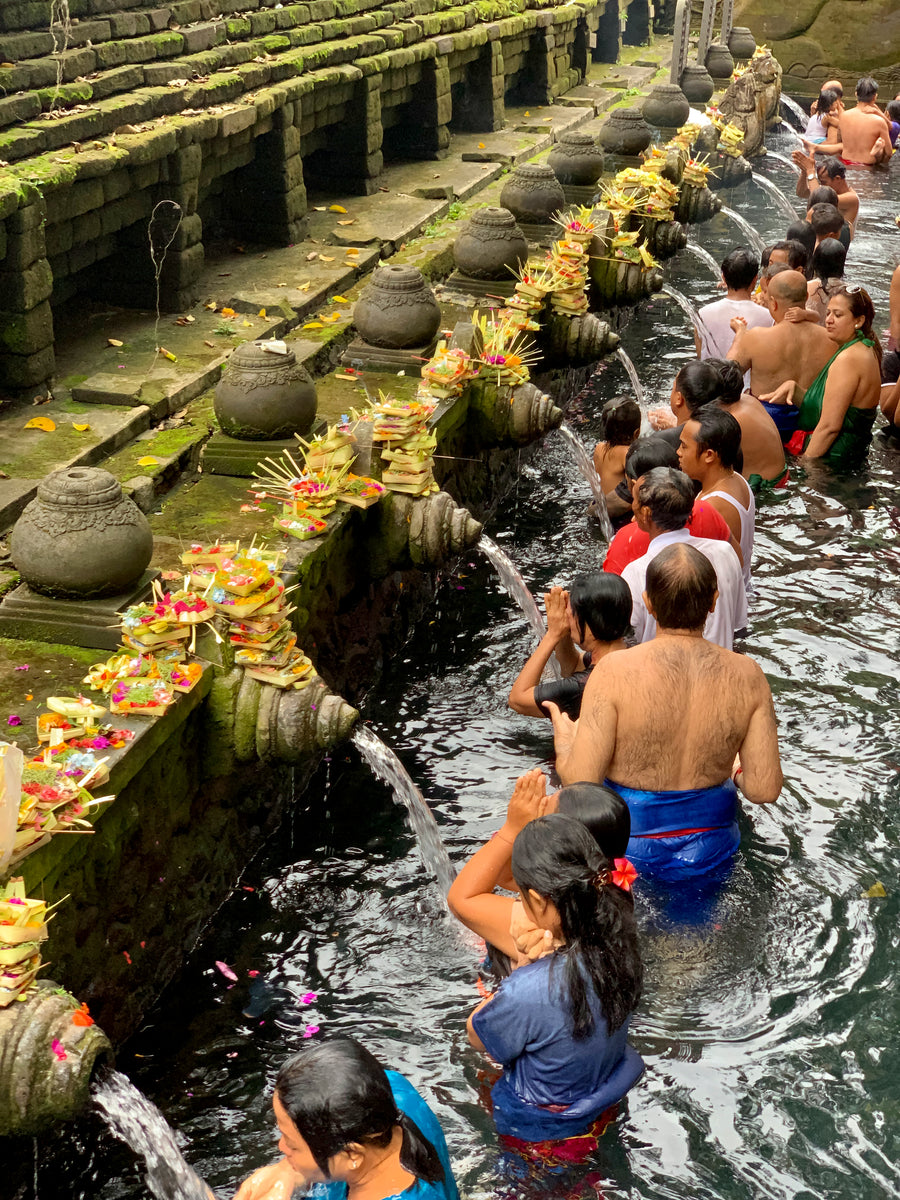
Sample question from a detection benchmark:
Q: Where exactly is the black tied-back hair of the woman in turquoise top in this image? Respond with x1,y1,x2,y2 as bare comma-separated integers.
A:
275,1036,445,1183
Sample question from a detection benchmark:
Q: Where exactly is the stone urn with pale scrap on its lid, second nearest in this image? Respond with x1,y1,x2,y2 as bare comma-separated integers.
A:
214,341,316,442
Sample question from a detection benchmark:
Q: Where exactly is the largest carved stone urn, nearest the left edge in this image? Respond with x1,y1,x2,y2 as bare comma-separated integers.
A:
10,467,154,600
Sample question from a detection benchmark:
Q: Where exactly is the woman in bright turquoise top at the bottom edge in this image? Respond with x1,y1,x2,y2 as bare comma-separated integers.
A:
235,1036,458,1200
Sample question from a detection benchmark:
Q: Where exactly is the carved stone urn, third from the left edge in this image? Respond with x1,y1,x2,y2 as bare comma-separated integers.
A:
353,265,440,350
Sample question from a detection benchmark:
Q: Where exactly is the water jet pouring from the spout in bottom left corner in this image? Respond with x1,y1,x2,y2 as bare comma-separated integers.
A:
92,1070,214,1200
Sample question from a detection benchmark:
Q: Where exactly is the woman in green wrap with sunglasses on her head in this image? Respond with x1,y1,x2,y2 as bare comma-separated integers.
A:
763,287,881,466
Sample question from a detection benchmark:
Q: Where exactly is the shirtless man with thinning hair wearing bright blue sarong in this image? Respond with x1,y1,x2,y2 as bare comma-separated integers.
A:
552,545,782,880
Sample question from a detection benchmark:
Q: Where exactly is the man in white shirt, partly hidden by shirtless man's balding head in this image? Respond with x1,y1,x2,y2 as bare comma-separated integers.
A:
622,467,746,650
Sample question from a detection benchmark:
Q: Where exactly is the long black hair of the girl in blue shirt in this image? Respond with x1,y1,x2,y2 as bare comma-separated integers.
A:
512,812,643,1039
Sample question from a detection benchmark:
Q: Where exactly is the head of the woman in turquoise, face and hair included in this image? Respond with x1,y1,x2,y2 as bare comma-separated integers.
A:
272,1036,444,1183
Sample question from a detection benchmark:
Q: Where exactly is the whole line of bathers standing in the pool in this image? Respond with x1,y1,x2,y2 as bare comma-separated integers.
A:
226,78,900,1200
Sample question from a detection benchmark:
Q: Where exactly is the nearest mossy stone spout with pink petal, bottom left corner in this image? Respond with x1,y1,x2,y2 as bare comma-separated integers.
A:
0,979,113,1138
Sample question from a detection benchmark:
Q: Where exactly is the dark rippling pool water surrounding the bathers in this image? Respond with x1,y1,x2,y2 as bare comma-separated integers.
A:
40,136,900,1200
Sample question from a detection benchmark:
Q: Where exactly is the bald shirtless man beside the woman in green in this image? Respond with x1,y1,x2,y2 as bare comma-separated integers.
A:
728,271,834,404
